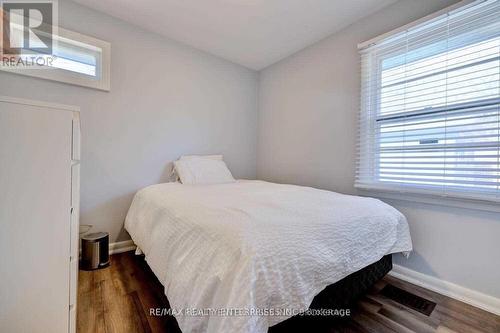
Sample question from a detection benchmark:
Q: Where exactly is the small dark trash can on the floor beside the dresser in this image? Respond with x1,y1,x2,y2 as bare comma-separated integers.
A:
80,232,109,271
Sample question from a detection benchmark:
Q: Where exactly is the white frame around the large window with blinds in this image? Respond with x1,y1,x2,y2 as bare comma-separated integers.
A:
354,0,500,205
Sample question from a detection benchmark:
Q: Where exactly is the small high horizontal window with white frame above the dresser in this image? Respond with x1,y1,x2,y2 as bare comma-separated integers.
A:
0,23,111,91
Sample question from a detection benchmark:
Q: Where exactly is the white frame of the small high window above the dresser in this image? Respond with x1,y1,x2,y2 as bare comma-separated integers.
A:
0,27,111,91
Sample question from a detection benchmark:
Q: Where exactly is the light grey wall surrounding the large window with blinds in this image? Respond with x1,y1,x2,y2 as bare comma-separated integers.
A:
257,0,500,297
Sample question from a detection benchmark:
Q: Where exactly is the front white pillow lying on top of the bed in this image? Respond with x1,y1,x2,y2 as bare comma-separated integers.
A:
174,157,235,185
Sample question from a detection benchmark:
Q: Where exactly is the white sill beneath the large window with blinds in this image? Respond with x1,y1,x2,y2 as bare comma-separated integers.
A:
357,188,500,213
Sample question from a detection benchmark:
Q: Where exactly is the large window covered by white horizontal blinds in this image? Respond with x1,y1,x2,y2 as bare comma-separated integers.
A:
356,0,500,201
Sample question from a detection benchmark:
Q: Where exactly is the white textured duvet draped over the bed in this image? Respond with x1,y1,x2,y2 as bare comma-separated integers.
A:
125,181,412,333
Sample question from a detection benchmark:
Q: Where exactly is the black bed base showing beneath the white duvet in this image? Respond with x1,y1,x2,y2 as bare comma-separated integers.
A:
269,254,392,333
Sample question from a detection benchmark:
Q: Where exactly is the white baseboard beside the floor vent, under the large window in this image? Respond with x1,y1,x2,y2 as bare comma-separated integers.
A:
389,265,500,315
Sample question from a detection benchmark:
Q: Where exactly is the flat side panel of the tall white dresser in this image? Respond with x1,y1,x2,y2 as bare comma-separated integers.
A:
0,100,73,333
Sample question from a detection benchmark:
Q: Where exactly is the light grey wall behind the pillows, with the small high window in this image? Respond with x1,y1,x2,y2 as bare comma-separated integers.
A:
0,1,257,242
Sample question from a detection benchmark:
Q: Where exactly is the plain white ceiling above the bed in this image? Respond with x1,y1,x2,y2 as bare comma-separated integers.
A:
75,0,397,70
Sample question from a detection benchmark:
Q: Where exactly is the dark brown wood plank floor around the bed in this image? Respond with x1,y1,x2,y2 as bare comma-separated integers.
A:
77,252,500,333
